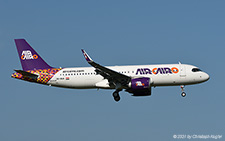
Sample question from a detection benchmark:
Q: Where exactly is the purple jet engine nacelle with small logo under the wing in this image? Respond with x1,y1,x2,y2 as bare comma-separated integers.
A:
126,77,151,96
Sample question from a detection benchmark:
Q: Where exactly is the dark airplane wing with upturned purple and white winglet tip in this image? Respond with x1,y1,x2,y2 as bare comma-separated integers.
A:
81,49,131,87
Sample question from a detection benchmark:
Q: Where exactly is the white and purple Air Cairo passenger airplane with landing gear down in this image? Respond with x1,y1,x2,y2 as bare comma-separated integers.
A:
12,39,210,102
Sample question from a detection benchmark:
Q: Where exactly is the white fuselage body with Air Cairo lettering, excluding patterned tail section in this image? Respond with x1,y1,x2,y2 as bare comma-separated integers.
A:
48,64,209,89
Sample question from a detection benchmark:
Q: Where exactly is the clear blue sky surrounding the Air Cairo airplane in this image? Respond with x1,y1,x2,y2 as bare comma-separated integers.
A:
0,0,225,141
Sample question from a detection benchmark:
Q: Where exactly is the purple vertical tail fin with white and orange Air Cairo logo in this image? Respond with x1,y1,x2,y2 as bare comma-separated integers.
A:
15,39,52,71
